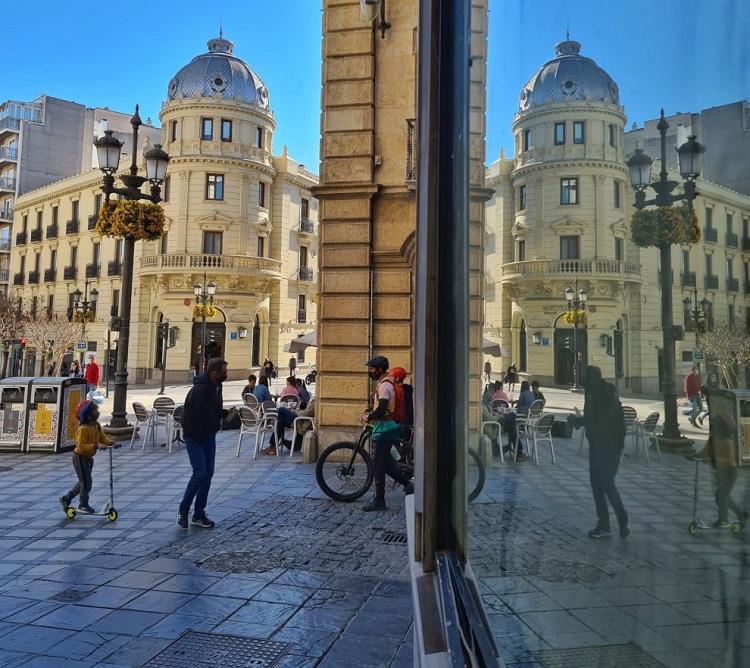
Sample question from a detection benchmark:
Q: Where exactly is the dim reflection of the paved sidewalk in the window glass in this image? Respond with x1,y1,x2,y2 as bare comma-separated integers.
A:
469,439,750,668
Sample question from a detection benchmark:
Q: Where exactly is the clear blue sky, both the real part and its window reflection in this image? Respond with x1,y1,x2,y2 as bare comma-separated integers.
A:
0,0,750,172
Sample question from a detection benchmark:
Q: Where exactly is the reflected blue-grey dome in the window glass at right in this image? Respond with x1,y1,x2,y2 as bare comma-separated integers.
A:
518,40,620,112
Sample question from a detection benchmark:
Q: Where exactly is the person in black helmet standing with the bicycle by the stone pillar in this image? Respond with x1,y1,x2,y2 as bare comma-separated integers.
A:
360,355,414,512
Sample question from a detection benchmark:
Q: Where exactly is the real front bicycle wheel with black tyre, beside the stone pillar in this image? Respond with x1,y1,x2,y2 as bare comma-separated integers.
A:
315,441,373,501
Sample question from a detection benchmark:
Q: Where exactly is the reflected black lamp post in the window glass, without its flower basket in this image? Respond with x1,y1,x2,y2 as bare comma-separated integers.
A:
628,109,706,449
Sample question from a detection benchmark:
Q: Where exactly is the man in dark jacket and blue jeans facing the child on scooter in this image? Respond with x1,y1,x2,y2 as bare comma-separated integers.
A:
177,357,227,529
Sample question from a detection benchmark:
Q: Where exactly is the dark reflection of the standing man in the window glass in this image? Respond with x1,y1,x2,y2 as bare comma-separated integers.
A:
574,366,630,538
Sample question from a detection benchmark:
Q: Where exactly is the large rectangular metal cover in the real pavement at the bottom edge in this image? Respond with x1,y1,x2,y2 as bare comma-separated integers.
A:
143,631,292,668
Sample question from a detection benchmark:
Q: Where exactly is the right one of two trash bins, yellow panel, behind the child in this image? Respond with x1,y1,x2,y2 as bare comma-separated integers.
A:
26,378,86,452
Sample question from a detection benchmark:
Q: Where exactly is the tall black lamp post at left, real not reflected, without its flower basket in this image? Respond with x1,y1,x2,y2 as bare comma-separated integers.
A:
94,105,169,433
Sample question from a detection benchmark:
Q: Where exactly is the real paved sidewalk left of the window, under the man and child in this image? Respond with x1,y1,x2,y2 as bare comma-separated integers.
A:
0,432,413,668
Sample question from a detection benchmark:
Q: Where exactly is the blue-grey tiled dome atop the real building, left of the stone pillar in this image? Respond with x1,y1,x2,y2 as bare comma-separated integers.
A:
167,35,269,109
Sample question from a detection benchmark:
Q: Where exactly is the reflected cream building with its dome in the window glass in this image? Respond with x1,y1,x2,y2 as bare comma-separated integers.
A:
485,40,750,392
